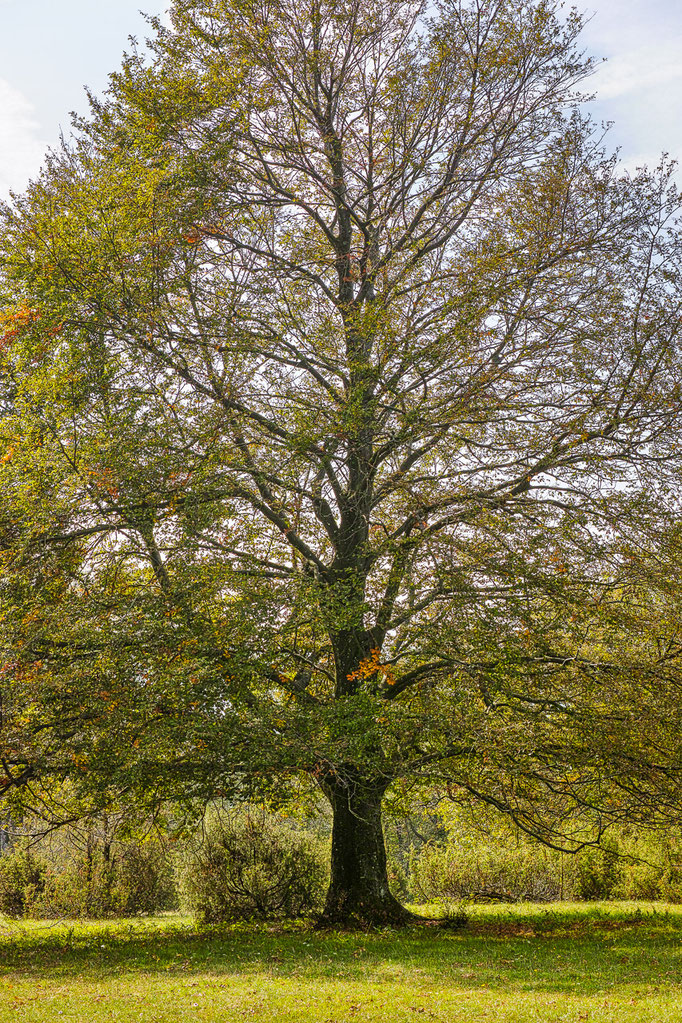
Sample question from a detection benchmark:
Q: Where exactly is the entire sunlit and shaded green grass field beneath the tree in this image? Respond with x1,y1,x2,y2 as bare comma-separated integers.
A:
0,903,682,1023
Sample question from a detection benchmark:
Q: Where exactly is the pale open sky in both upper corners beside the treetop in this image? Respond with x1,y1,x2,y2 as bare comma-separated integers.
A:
0,0,682,197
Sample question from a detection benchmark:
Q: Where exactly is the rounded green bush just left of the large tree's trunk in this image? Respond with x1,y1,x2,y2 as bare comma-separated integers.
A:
180,809,327,923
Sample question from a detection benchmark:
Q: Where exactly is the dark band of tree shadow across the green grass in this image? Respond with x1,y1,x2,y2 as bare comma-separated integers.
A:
0,909,682,996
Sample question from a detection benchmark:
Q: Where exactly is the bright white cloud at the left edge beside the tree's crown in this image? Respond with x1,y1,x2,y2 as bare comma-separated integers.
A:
0,77,47,198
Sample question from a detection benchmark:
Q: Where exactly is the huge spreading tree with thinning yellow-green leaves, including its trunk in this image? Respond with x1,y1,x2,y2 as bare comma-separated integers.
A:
0,0,682,923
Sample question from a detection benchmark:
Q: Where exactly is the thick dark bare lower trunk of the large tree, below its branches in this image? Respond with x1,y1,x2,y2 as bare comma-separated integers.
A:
320,771,411,927
